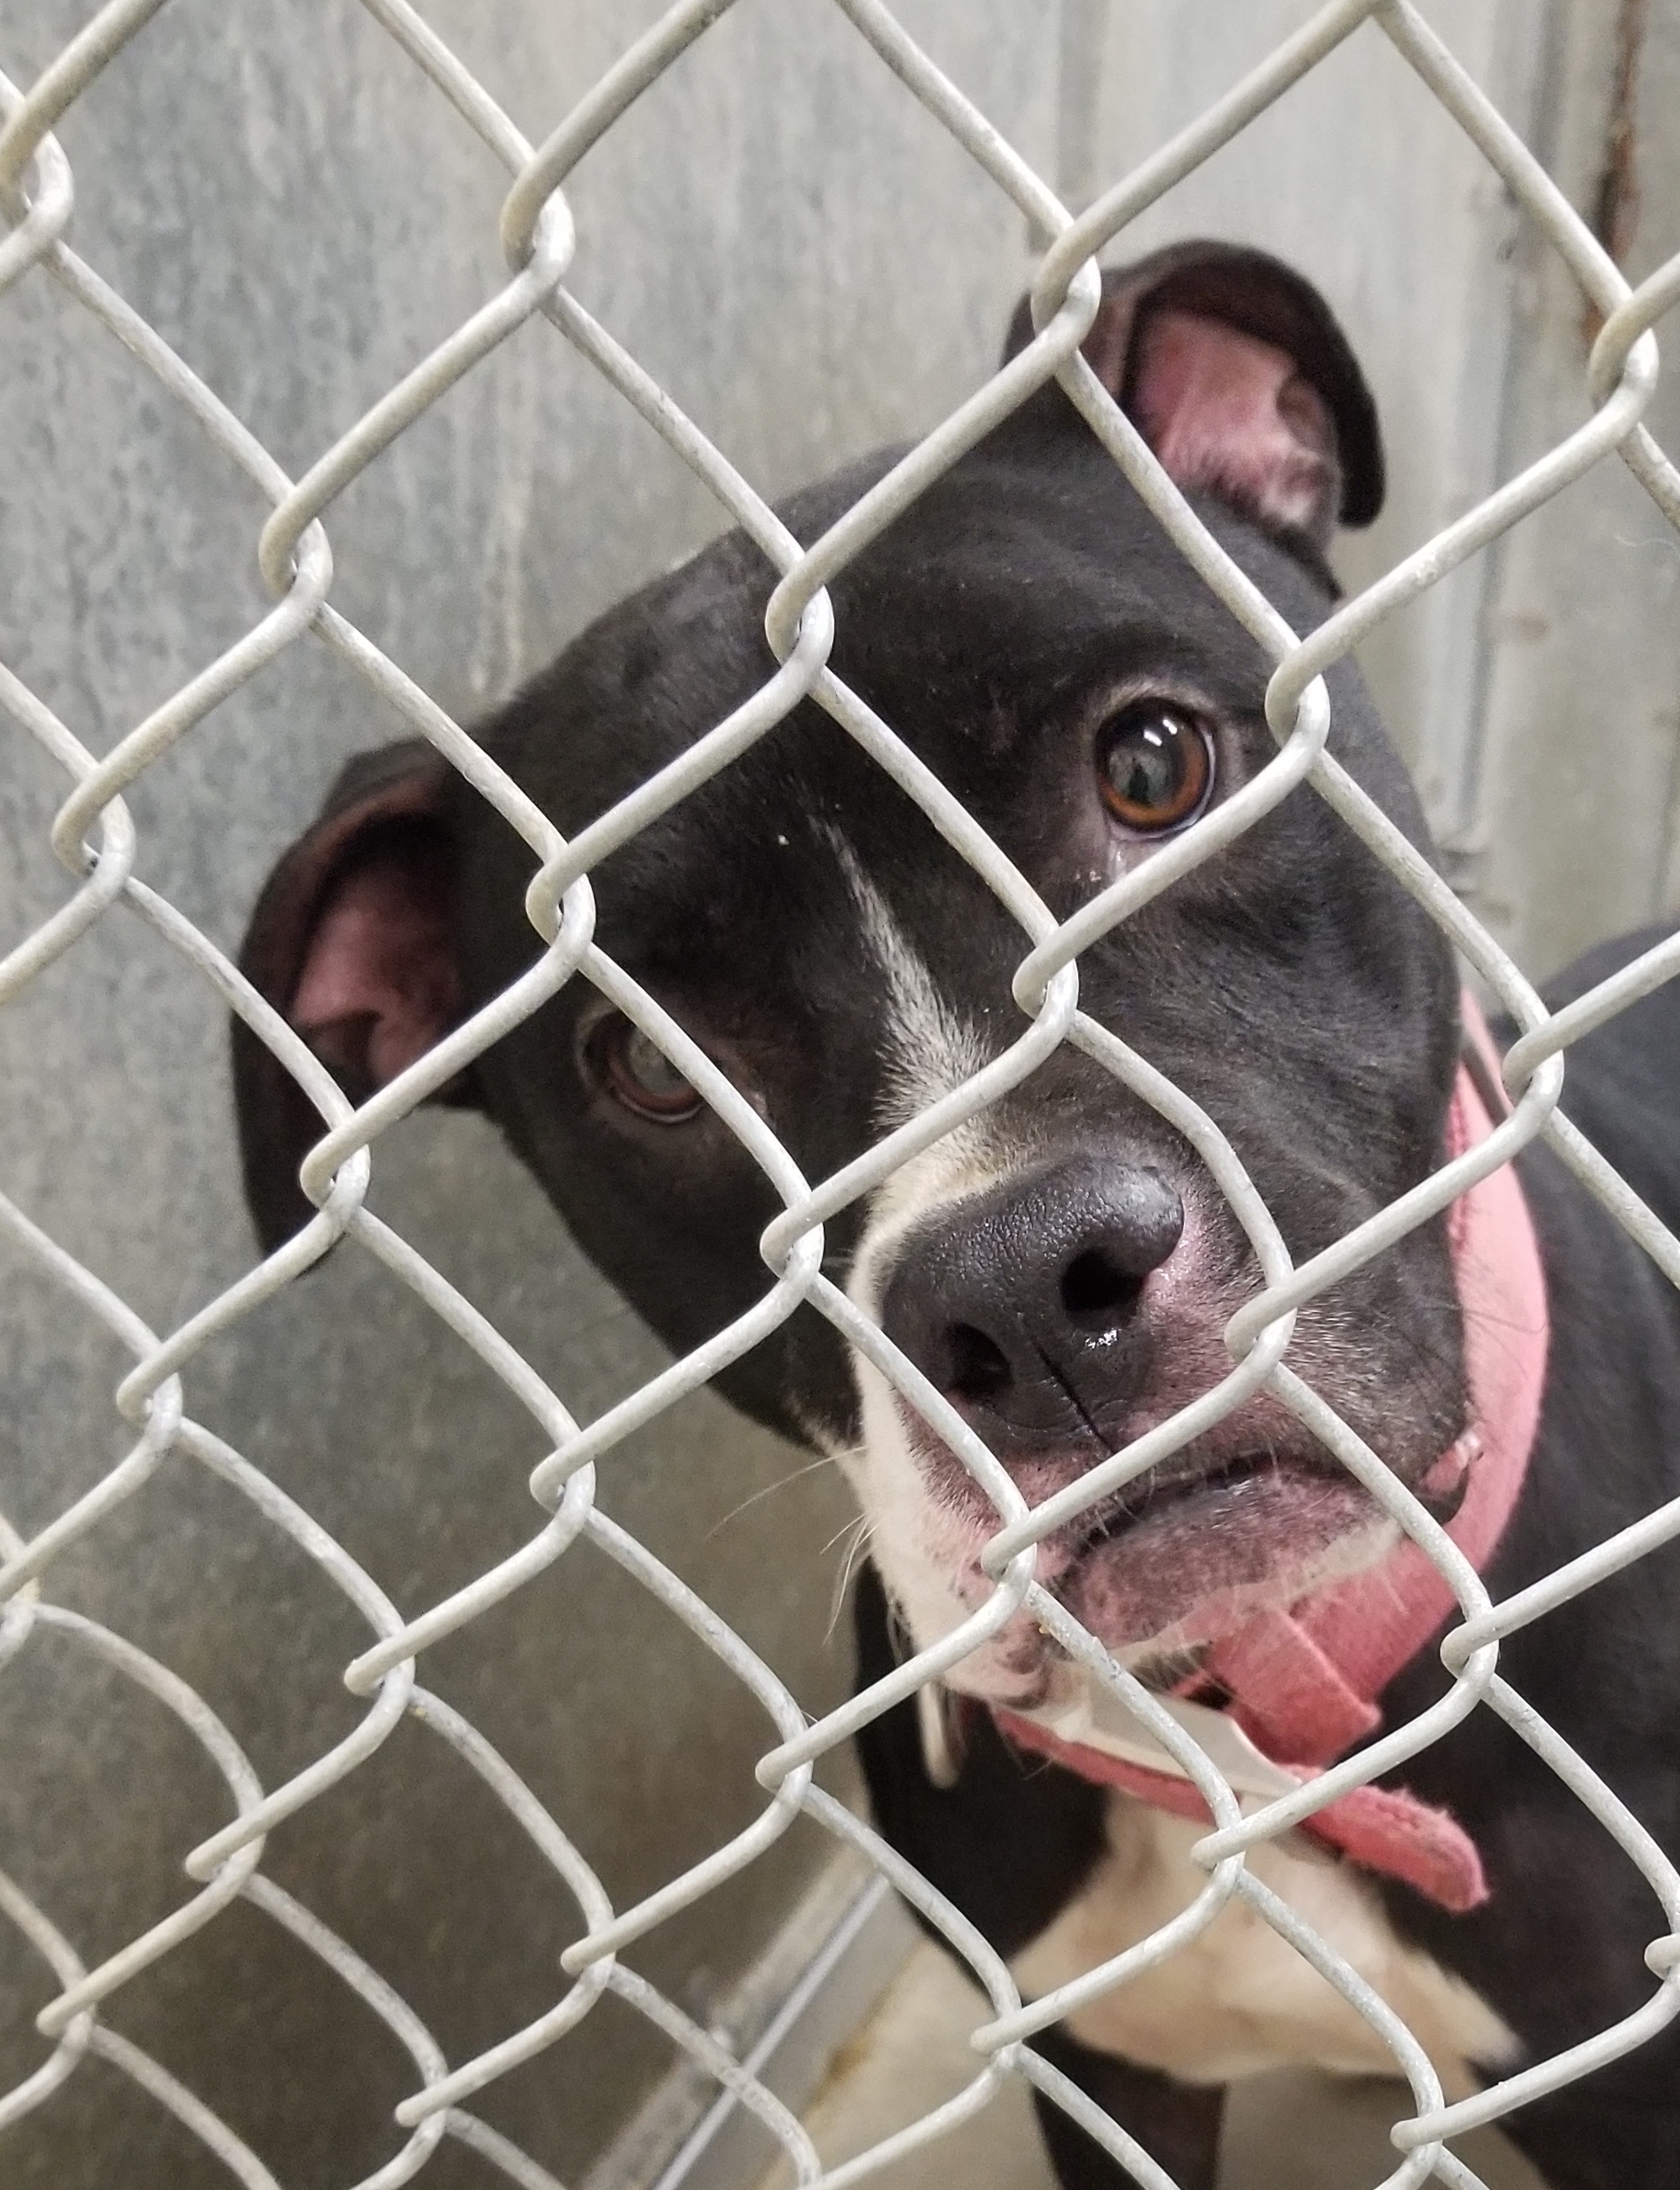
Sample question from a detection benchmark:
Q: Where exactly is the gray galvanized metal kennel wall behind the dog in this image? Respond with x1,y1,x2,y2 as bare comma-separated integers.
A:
0,0,1680,2190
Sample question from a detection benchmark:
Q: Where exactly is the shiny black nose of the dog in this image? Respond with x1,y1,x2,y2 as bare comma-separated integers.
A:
880,1161,1185,1445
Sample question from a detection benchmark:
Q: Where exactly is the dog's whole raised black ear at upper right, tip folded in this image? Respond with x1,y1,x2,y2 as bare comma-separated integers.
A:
1003,243,1382,548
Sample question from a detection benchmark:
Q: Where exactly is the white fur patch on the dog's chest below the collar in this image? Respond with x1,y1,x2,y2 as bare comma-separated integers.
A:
1014,1793,1518,2098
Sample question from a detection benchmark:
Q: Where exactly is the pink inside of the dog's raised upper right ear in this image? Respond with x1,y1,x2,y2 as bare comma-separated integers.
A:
1131,306,1340,539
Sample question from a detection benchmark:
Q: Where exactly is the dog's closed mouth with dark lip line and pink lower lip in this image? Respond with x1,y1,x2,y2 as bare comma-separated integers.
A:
1045,1452,1389,1651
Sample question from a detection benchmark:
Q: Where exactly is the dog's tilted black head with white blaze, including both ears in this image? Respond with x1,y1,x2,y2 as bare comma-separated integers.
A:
239,248,1463,1704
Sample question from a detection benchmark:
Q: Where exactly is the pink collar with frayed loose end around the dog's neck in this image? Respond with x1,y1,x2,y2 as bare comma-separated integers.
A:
997,996,1546,1912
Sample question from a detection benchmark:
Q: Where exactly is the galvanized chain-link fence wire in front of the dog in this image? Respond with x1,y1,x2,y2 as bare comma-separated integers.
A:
0,0,1680,2190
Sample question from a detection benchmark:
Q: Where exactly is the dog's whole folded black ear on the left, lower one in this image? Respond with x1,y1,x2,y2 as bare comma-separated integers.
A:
233,738,476,1253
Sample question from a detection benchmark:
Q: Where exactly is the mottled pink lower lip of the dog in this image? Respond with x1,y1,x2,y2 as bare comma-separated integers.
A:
1061,1467,1371,1649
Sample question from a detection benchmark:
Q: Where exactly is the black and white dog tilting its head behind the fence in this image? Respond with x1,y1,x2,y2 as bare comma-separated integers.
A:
237,245,1680,2190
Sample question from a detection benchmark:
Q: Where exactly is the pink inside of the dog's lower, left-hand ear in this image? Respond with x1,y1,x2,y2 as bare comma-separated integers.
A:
287,854,460,1087
